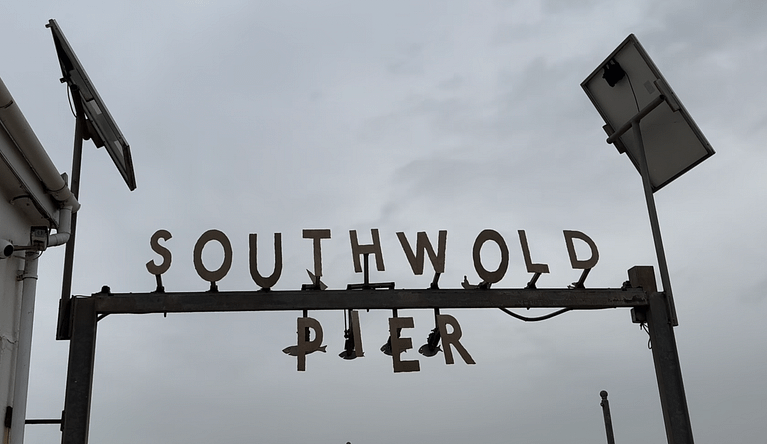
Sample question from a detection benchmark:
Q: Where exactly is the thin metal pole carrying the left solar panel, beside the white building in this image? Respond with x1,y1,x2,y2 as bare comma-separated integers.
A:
56,89,86,340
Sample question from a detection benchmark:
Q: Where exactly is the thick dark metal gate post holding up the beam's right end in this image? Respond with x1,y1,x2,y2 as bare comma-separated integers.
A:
629,267,693,444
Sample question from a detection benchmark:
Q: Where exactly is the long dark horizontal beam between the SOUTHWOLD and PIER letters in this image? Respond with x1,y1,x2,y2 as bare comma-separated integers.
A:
93,288,649,314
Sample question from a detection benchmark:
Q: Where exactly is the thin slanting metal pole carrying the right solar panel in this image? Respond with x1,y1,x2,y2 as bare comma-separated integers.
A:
631,121,679,325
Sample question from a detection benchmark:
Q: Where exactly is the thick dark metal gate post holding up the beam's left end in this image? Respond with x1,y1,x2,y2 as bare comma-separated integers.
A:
61,297,96,444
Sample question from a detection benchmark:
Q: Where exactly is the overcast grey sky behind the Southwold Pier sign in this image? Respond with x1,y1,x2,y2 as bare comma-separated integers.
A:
0,0,767,444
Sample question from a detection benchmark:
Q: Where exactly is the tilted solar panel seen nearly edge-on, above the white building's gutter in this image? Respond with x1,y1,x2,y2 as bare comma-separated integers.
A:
46,19,136,191
